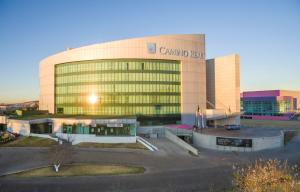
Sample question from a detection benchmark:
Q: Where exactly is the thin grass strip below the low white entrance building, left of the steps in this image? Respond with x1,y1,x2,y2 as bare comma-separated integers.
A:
76,142,147,149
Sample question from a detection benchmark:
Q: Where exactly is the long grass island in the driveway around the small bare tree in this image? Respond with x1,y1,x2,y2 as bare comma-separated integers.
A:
12,164,145,177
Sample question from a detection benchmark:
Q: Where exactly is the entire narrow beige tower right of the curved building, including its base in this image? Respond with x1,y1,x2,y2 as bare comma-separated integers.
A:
206,54,240,127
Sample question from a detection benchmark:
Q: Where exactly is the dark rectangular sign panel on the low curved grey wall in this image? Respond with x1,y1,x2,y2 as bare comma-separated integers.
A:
216,137,252,147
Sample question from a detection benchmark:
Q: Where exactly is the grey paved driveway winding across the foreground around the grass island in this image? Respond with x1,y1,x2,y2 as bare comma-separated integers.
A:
0,136,300,192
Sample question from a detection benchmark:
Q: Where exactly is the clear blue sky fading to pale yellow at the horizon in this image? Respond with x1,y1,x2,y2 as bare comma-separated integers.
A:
0,0,300,103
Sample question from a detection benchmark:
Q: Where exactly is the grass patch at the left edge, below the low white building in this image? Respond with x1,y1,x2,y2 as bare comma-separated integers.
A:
0,136,57,147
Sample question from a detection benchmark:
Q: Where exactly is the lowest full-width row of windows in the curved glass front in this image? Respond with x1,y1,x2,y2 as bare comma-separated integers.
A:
56,105,180,115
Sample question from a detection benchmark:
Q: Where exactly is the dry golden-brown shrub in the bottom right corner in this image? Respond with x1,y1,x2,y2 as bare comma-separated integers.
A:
233,159,298,192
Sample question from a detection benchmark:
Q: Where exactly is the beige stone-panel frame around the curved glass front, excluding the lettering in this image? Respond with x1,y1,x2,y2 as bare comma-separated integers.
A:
39,34,206,122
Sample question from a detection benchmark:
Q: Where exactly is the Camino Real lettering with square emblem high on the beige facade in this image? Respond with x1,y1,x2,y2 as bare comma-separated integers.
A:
147,43,204,59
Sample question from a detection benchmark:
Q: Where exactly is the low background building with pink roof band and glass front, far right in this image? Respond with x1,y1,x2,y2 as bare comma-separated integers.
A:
241,90,300,120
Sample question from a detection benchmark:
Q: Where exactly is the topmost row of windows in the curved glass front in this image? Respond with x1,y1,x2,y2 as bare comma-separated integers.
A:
56,60,180,74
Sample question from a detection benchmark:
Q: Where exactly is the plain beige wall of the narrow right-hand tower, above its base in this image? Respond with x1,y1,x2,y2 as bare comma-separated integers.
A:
206,54,240,114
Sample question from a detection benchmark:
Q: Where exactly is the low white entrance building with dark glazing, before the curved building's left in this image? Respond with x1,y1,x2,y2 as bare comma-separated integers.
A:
0,116,137,144
